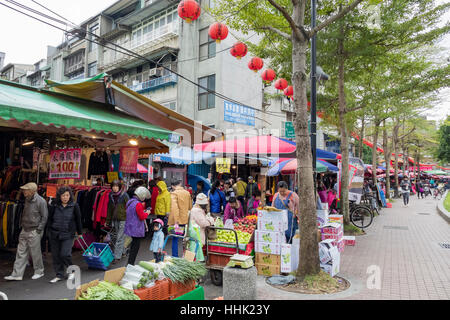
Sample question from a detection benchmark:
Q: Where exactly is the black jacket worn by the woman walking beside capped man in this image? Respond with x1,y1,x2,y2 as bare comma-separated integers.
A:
48,202,83,240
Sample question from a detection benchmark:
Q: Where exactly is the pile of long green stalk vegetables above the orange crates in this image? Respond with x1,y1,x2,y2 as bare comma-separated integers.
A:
158,257,206,282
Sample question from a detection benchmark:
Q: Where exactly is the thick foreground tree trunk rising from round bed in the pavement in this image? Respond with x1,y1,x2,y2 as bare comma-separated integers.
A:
292,1,320,280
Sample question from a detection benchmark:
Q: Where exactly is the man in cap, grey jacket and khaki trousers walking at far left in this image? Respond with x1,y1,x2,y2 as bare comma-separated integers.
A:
5,182,48,280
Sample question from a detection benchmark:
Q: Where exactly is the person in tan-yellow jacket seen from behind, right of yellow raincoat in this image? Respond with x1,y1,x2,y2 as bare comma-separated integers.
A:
169,180,192,257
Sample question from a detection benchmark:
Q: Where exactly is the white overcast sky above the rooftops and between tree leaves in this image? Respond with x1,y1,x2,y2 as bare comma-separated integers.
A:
0,0,450,120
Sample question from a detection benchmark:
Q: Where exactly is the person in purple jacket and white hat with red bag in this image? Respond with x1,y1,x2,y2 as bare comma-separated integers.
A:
124,187,150,265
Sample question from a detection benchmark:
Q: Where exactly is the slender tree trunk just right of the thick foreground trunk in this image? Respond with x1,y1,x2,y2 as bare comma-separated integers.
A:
338,23,350,224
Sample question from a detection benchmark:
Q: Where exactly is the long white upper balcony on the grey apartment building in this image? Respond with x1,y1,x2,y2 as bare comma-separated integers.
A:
102,22,178,71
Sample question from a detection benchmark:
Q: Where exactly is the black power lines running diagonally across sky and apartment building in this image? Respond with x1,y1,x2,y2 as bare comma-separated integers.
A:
0,0,284,124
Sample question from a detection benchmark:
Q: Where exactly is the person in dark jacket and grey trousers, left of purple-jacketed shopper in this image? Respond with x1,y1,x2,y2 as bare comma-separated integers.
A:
106,180,130,263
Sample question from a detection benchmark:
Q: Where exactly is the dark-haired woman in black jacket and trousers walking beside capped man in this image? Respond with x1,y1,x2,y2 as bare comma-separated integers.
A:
47,186,82,283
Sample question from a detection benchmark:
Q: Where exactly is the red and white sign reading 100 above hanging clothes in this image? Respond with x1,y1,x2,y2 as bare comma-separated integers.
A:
48,148,81,179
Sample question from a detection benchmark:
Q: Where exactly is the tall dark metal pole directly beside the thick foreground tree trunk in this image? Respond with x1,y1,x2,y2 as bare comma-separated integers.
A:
310,0,317,175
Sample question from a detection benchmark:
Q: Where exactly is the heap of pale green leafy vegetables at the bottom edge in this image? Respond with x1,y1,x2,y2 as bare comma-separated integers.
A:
78,281,140,300
